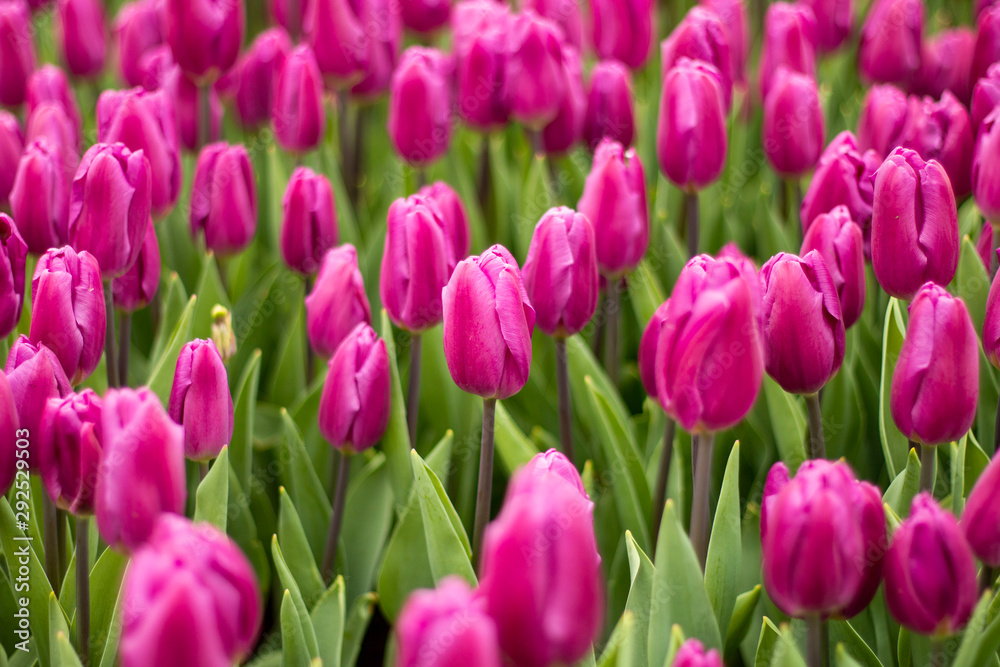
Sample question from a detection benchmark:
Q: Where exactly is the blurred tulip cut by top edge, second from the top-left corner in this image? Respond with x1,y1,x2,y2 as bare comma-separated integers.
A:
56,0,108,77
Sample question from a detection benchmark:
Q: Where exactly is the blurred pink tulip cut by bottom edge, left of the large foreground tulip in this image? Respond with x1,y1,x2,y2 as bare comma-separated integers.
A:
396,576,502,667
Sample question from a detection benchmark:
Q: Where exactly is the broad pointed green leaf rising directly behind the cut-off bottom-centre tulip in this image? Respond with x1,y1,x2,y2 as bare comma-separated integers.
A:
378,452,476,622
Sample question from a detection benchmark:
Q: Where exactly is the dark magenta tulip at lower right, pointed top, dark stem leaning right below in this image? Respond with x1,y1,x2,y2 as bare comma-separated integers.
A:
885,493,977,637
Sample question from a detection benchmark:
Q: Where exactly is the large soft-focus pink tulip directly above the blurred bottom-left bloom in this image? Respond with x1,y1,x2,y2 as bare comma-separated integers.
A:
96,388,187,551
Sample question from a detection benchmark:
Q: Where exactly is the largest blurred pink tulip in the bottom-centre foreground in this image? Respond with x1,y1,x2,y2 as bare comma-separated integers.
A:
480,454,604,667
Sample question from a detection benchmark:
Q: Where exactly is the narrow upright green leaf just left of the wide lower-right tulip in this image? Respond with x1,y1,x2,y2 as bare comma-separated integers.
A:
705,441,743,630
